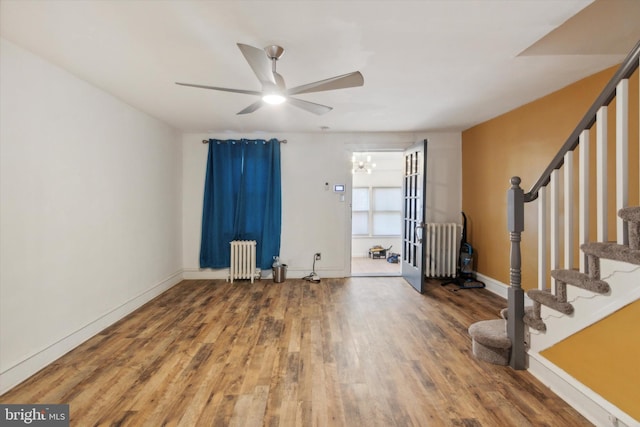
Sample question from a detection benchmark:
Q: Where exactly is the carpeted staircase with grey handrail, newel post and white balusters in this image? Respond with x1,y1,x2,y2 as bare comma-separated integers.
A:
469,42,640,425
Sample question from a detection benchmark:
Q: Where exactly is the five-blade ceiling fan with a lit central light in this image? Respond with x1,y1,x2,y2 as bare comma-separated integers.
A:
176,43,364,115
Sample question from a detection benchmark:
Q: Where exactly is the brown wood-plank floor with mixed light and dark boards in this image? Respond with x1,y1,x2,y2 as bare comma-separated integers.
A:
0,277,591,427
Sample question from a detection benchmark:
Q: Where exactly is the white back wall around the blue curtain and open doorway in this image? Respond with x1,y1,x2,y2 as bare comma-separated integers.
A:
183,132,462,279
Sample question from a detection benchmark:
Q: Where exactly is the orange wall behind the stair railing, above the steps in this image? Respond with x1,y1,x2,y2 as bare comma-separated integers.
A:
462,66,638,289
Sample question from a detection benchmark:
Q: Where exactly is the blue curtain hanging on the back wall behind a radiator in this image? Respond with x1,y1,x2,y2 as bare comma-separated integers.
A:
200,139,282,269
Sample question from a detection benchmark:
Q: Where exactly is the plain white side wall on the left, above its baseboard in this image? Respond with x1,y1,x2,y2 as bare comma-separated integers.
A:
0,40,182,392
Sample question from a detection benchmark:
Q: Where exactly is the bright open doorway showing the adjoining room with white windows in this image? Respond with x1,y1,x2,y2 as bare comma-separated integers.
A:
351,151,404,276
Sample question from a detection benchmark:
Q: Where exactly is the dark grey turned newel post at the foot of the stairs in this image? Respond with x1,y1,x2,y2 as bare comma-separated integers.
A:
507,176,526,370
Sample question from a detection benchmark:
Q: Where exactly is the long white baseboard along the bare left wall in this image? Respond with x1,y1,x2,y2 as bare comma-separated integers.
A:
0,270,183,394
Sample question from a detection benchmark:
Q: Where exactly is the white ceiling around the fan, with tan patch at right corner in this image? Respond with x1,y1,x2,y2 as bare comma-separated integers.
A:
0,0,640,133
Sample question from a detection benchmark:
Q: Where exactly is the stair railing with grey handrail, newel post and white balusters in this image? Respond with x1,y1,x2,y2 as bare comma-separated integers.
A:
507,38,640,369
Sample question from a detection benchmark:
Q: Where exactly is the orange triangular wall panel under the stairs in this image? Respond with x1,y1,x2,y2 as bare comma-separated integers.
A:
540,301,640,422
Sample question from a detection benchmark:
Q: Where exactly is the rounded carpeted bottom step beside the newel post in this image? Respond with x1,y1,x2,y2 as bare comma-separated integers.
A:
469,319,511,366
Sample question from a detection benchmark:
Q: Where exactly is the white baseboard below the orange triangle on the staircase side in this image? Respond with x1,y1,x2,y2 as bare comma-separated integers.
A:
529,352,640,427
